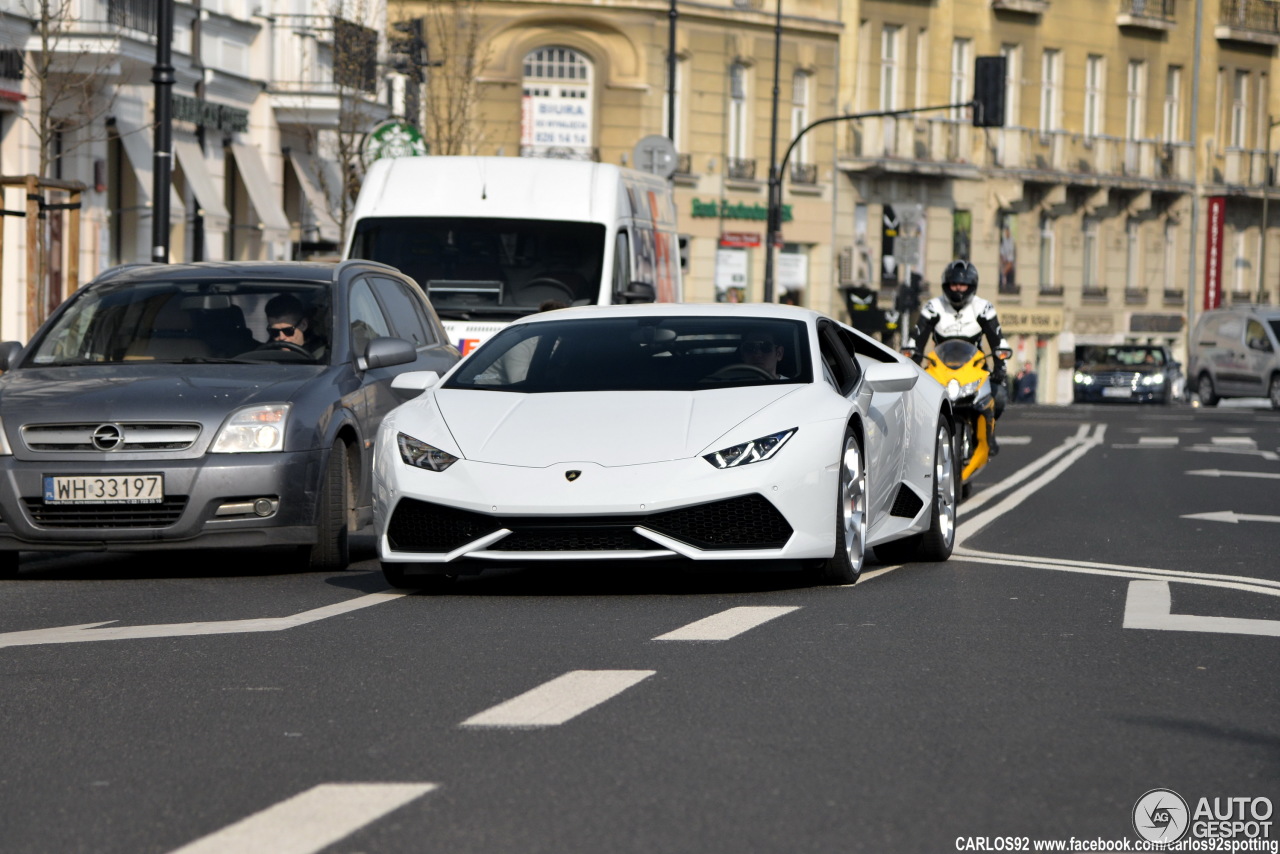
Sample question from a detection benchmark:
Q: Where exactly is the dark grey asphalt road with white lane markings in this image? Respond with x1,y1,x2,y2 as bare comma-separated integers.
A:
0,406,1280,854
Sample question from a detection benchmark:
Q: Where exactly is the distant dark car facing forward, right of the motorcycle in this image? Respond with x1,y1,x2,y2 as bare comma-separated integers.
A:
1073,344,1184,403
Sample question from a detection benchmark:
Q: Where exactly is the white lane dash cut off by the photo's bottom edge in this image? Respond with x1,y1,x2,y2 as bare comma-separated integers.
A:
172,782,436,854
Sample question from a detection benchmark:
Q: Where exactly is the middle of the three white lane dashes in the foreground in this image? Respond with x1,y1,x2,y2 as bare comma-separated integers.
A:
462,670,657,727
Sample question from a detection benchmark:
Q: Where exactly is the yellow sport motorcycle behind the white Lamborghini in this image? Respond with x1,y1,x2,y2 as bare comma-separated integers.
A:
923,338,996,498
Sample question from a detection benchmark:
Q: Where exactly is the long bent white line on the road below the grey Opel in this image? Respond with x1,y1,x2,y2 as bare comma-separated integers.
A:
0,590,407,648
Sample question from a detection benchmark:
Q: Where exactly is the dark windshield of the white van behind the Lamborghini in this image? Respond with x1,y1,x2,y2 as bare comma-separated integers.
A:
351,216,604,320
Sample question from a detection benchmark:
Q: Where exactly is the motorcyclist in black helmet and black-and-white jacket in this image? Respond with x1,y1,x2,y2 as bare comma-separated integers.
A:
902,260,1012,456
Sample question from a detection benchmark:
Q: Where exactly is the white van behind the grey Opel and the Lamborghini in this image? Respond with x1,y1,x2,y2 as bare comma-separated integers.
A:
346,156,682,355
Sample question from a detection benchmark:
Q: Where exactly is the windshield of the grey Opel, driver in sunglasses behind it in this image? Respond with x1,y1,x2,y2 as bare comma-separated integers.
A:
26,279,332,367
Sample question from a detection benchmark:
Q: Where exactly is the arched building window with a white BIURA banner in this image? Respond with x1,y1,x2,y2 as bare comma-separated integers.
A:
520,47,595,160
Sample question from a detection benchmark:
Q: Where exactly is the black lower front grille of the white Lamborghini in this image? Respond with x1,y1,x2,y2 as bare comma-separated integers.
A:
387,495,792,553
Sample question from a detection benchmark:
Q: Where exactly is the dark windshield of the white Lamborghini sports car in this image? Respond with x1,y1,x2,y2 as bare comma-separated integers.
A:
444,316,813,393
